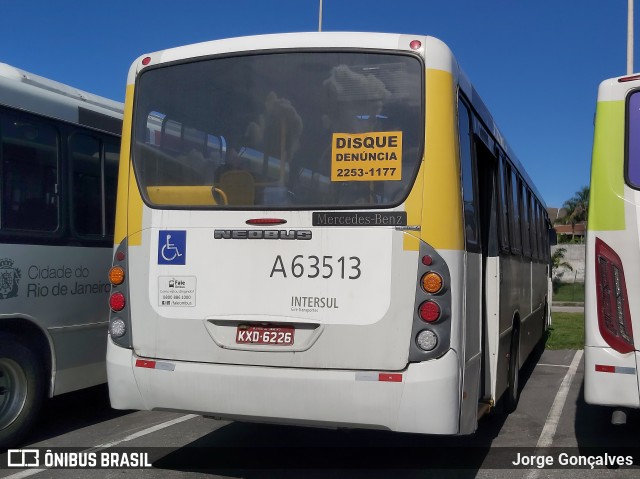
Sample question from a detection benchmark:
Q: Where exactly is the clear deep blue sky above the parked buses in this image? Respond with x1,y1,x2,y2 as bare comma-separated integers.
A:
0,0,640,206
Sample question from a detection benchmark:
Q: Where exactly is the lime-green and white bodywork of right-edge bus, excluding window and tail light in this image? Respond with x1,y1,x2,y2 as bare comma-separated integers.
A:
585,78,640,408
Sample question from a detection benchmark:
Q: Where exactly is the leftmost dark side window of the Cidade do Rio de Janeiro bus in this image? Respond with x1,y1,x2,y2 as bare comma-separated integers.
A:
0,112,59,231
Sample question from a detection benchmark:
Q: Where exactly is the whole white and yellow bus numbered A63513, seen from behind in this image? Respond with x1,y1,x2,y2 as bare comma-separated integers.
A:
107,33,550,434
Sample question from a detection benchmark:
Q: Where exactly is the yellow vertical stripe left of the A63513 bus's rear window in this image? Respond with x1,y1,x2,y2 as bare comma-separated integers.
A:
114,85,142,245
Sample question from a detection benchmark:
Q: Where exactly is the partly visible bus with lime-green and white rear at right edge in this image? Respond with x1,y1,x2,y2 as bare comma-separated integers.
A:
584,75,640,424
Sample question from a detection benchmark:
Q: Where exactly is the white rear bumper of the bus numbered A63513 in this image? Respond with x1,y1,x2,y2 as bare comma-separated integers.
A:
107,341,461,434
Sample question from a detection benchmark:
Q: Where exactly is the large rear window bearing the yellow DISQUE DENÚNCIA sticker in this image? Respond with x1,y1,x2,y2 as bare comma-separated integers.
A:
133,51,424,209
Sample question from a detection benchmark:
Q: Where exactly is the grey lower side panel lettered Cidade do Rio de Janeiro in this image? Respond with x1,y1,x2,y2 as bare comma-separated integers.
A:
0,240,111,395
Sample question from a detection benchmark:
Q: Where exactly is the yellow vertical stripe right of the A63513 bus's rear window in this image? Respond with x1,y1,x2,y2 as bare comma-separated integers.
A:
404,69,464,250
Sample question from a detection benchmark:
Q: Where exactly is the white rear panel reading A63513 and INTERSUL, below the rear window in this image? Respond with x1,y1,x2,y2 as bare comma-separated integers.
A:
129,224,436,370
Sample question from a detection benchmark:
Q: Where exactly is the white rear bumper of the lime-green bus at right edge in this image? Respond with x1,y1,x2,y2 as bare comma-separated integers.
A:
584,346,640,408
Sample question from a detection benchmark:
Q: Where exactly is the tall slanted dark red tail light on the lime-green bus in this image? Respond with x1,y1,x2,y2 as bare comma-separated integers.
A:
596,238,635,353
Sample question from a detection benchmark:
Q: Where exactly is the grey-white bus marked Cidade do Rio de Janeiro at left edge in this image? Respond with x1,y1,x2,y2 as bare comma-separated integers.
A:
0,64,123,448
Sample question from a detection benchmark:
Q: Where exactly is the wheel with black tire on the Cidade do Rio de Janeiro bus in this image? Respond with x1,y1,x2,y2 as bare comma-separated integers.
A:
0,334,45,449
